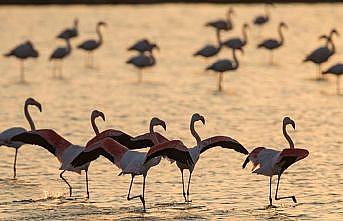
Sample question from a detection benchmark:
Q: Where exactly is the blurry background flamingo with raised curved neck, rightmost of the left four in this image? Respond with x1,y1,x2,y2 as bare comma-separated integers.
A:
77,21,107,67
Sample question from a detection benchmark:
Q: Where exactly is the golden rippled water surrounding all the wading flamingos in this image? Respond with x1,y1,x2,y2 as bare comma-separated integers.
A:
0,4,343,220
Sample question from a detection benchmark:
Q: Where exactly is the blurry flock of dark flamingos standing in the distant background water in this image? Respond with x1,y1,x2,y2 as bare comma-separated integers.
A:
5,3,343,94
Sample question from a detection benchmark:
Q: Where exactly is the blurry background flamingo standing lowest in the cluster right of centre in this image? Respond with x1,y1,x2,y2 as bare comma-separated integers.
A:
206,49,243,91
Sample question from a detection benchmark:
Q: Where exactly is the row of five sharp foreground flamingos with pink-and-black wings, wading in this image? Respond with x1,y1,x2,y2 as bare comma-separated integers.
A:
0,98,309,211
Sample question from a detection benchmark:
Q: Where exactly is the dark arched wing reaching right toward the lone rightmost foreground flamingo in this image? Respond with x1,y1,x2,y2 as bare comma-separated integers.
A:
200,136,249,155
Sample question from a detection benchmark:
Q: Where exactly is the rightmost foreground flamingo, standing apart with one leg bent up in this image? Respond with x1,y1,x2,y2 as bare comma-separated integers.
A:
242,117,309,207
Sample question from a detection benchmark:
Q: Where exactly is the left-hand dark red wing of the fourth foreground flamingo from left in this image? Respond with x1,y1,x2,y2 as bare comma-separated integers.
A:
144,140,194,165
